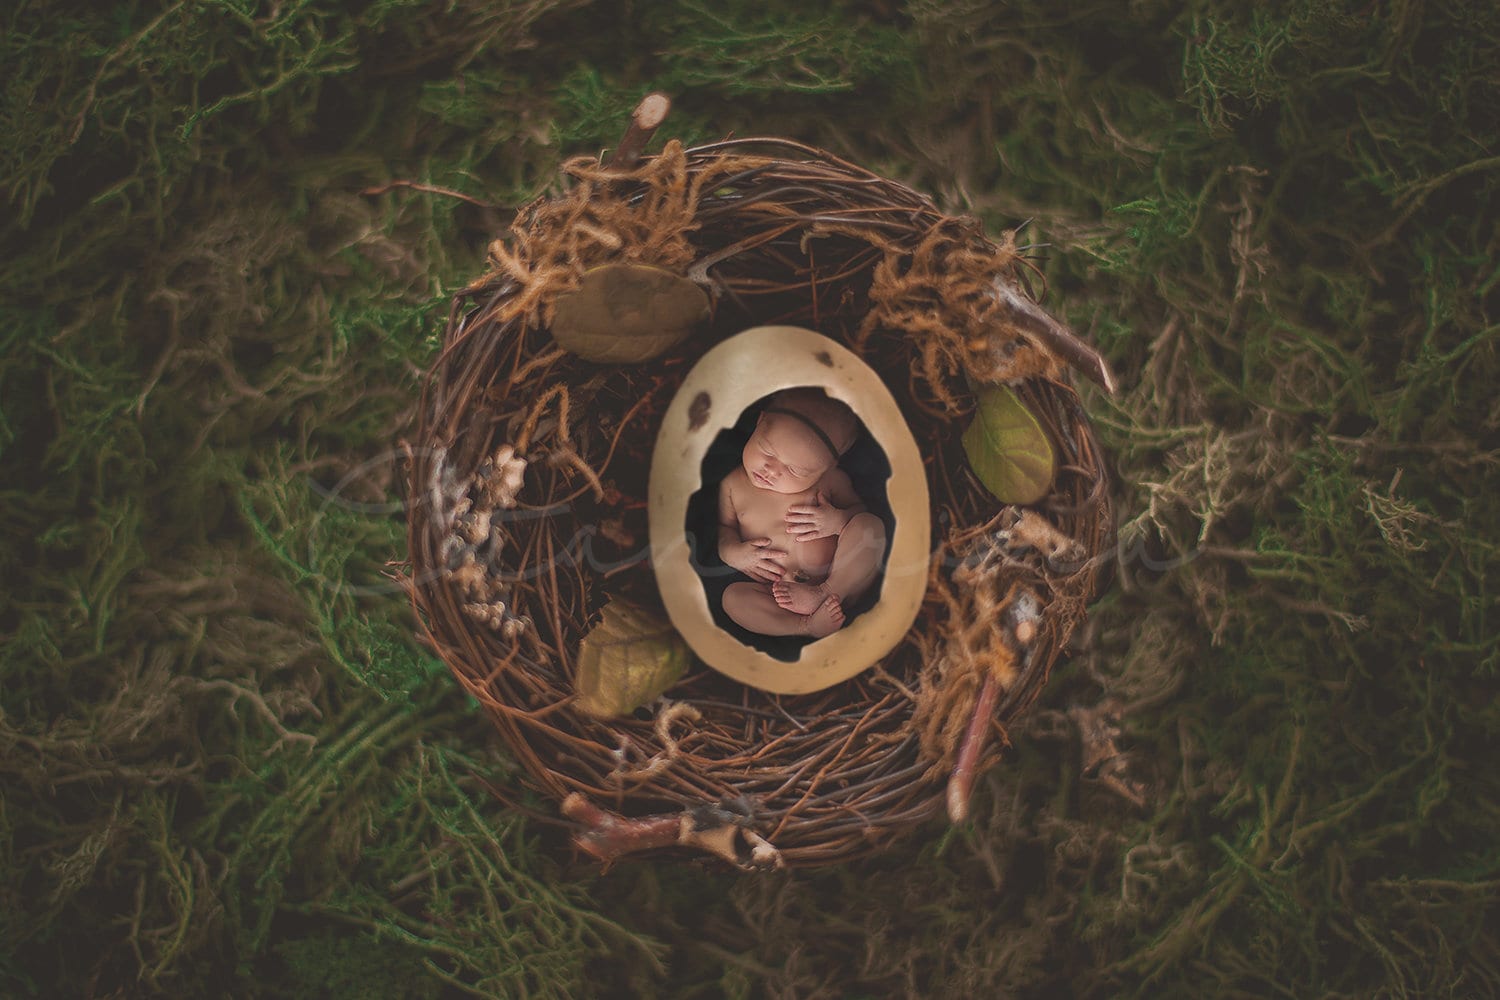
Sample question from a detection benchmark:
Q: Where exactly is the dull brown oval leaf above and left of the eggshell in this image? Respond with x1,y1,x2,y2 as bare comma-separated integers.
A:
552,264,708,364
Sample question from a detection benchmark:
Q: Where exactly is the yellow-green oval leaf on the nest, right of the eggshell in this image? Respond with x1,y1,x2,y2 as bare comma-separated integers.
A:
963,385,1058,504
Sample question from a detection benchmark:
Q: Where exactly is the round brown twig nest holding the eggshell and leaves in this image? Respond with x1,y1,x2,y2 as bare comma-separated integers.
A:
408,97,1112,868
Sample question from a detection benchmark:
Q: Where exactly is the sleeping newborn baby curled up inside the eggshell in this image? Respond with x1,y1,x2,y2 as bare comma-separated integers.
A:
719,388,885,639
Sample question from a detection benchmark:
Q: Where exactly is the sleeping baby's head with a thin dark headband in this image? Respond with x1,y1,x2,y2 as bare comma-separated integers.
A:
741,388,860,493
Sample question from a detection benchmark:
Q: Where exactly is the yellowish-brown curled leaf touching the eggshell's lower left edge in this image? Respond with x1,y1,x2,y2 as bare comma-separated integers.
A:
578,600,687,718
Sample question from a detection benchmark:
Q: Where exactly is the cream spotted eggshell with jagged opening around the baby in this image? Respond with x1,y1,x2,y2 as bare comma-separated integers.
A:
648,327,930,694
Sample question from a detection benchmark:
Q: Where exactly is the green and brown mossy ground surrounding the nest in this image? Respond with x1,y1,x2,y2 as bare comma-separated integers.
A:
0,0,1500,997
